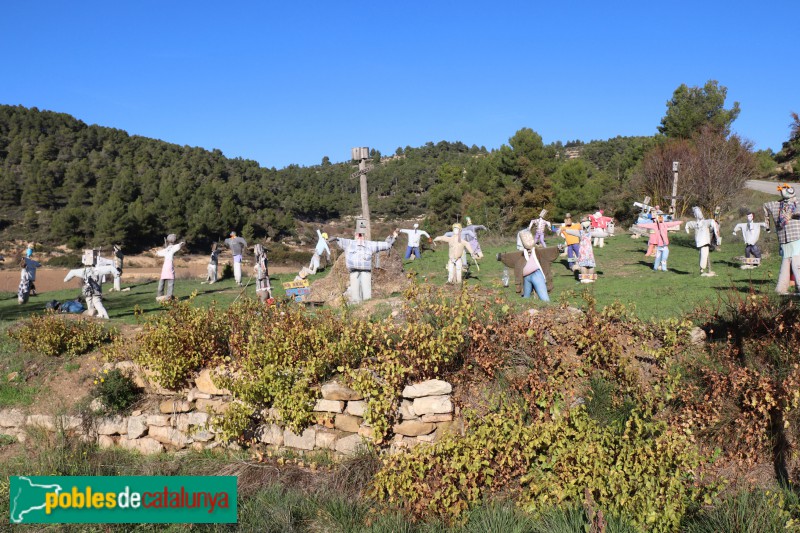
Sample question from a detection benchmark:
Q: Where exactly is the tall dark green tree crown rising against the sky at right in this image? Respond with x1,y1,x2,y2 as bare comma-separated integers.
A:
658,80,740,139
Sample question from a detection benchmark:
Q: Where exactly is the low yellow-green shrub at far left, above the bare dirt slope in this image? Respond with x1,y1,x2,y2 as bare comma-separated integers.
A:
8,312,117,357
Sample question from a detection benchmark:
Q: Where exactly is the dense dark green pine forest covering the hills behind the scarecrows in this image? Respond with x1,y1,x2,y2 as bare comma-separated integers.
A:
0,106,680,254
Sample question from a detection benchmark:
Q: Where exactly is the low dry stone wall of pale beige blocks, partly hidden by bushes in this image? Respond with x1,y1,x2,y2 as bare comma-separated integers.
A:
0,362,456,455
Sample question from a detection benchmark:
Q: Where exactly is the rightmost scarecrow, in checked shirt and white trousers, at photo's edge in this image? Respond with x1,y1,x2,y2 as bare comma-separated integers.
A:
764,184,800,294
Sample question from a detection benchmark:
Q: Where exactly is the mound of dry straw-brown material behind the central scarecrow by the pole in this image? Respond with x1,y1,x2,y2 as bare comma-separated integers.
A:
309,249,411,307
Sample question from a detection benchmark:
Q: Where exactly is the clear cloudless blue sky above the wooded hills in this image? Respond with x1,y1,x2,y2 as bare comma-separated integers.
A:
0,0,800,168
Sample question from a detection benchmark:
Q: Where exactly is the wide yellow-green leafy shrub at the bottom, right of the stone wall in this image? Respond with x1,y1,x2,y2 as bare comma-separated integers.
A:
374,407,716,531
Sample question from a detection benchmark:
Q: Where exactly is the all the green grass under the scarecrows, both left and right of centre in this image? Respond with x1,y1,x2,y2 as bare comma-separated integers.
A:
0,199,779,323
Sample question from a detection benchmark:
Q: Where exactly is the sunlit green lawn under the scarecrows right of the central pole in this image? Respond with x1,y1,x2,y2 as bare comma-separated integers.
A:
407,223,779,318
